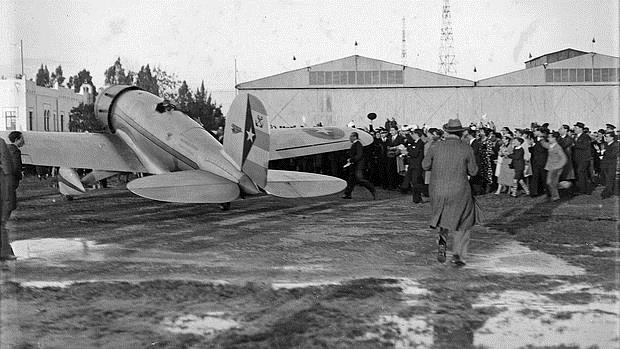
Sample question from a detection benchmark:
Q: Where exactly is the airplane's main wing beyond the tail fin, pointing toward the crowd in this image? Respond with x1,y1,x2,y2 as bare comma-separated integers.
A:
269,127,373,160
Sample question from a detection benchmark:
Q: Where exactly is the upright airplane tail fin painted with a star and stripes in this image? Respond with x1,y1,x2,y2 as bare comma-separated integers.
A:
224,93,270,191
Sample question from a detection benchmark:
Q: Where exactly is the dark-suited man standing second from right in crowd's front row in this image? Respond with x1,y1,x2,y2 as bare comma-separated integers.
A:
573,122,592,195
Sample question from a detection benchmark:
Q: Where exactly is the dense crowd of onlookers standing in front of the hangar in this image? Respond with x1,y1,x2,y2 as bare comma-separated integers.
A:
342,120,618,202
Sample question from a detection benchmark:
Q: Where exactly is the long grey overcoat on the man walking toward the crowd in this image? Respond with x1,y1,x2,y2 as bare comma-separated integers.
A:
422,135,480,231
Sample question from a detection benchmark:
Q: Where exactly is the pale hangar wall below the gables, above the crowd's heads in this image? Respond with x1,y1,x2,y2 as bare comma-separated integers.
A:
243,85,620,128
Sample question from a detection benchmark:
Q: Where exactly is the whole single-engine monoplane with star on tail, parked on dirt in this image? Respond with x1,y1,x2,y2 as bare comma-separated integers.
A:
0,85,372,203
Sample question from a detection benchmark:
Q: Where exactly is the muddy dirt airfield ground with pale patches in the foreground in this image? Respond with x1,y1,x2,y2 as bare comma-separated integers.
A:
0,177,620,348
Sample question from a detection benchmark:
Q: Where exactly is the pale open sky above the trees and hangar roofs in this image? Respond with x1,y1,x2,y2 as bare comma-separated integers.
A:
0,0,620,109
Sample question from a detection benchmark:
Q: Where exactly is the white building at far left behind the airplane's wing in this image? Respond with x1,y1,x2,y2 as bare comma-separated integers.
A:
0,78,93,132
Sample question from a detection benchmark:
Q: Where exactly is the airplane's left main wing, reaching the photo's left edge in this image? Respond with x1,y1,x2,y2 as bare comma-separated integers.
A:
0,131,148,172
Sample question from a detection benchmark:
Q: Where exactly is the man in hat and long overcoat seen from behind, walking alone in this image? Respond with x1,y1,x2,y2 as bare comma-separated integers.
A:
422,119,480,266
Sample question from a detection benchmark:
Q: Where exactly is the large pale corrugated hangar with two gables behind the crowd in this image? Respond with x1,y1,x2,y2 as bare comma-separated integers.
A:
236,49,620,129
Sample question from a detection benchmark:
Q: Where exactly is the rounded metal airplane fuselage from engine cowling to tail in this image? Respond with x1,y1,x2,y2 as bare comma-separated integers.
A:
96,88,244,183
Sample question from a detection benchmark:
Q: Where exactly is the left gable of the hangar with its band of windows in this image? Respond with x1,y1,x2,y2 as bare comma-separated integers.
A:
236,55,474,90
